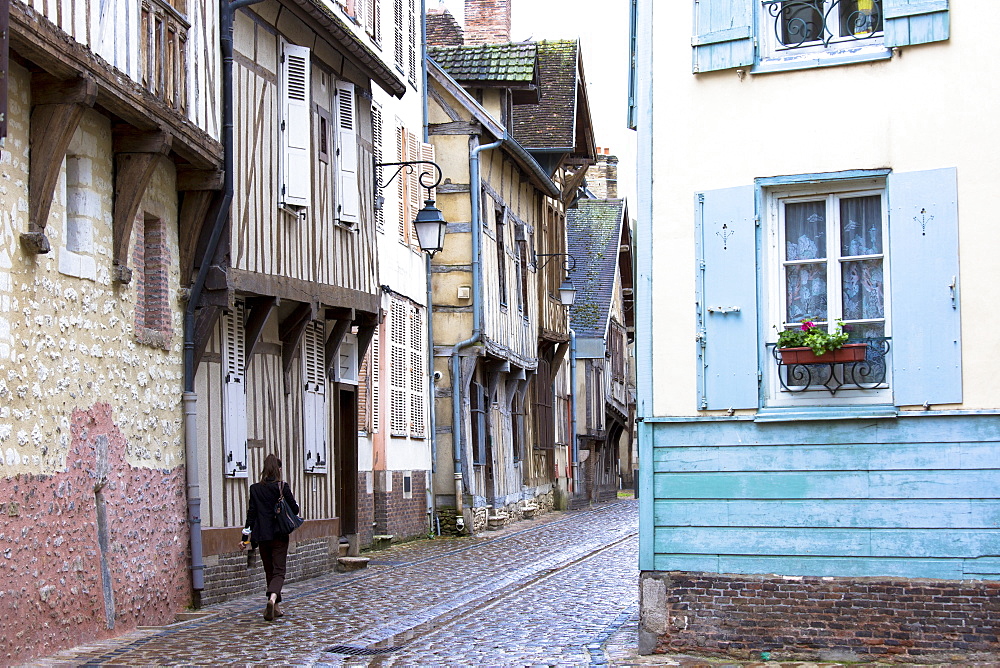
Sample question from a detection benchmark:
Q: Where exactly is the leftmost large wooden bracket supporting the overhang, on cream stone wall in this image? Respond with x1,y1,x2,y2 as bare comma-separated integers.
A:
21,73,97,253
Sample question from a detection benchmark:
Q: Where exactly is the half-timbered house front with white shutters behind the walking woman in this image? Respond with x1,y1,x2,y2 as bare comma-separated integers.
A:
190,0,406,600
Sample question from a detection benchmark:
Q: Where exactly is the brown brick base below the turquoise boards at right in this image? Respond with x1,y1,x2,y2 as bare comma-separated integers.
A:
640,572,1000,661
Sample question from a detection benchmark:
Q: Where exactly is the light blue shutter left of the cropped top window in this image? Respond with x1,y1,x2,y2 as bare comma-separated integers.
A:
691,0,754,72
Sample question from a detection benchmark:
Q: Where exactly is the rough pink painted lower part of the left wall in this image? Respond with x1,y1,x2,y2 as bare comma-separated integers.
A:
0,403,190,665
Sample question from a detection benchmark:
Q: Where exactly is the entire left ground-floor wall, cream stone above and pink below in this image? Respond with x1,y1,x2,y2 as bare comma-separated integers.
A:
0,63,190,664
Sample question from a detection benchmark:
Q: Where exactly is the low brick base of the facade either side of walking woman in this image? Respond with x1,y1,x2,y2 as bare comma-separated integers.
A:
201,534,340,605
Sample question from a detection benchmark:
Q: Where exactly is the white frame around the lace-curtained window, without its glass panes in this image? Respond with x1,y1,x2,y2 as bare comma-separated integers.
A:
758,176,893,408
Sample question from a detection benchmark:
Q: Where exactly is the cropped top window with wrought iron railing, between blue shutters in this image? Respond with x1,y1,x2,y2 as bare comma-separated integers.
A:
763,0,882,49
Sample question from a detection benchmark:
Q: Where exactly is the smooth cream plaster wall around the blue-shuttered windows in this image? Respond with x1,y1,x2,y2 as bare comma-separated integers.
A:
650,0,1000,415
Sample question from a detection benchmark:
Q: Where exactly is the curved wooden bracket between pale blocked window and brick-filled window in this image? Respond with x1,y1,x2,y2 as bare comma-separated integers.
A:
111,126,172,283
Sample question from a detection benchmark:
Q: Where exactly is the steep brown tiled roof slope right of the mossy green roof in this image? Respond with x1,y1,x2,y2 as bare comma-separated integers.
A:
512,40,583,151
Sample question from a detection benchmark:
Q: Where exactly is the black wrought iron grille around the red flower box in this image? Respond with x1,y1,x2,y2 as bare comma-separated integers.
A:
767,337,892,396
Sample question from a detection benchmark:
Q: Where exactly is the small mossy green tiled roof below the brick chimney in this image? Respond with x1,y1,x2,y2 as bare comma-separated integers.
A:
427,42,537,84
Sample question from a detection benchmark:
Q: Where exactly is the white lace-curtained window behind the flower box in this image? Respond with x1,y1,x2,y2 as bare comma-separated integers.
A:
768,182,890,403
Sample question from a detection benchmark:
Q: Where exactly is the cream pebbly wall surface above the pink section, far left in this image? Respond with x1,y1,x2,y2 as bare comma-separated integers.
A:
0,65,183,477
